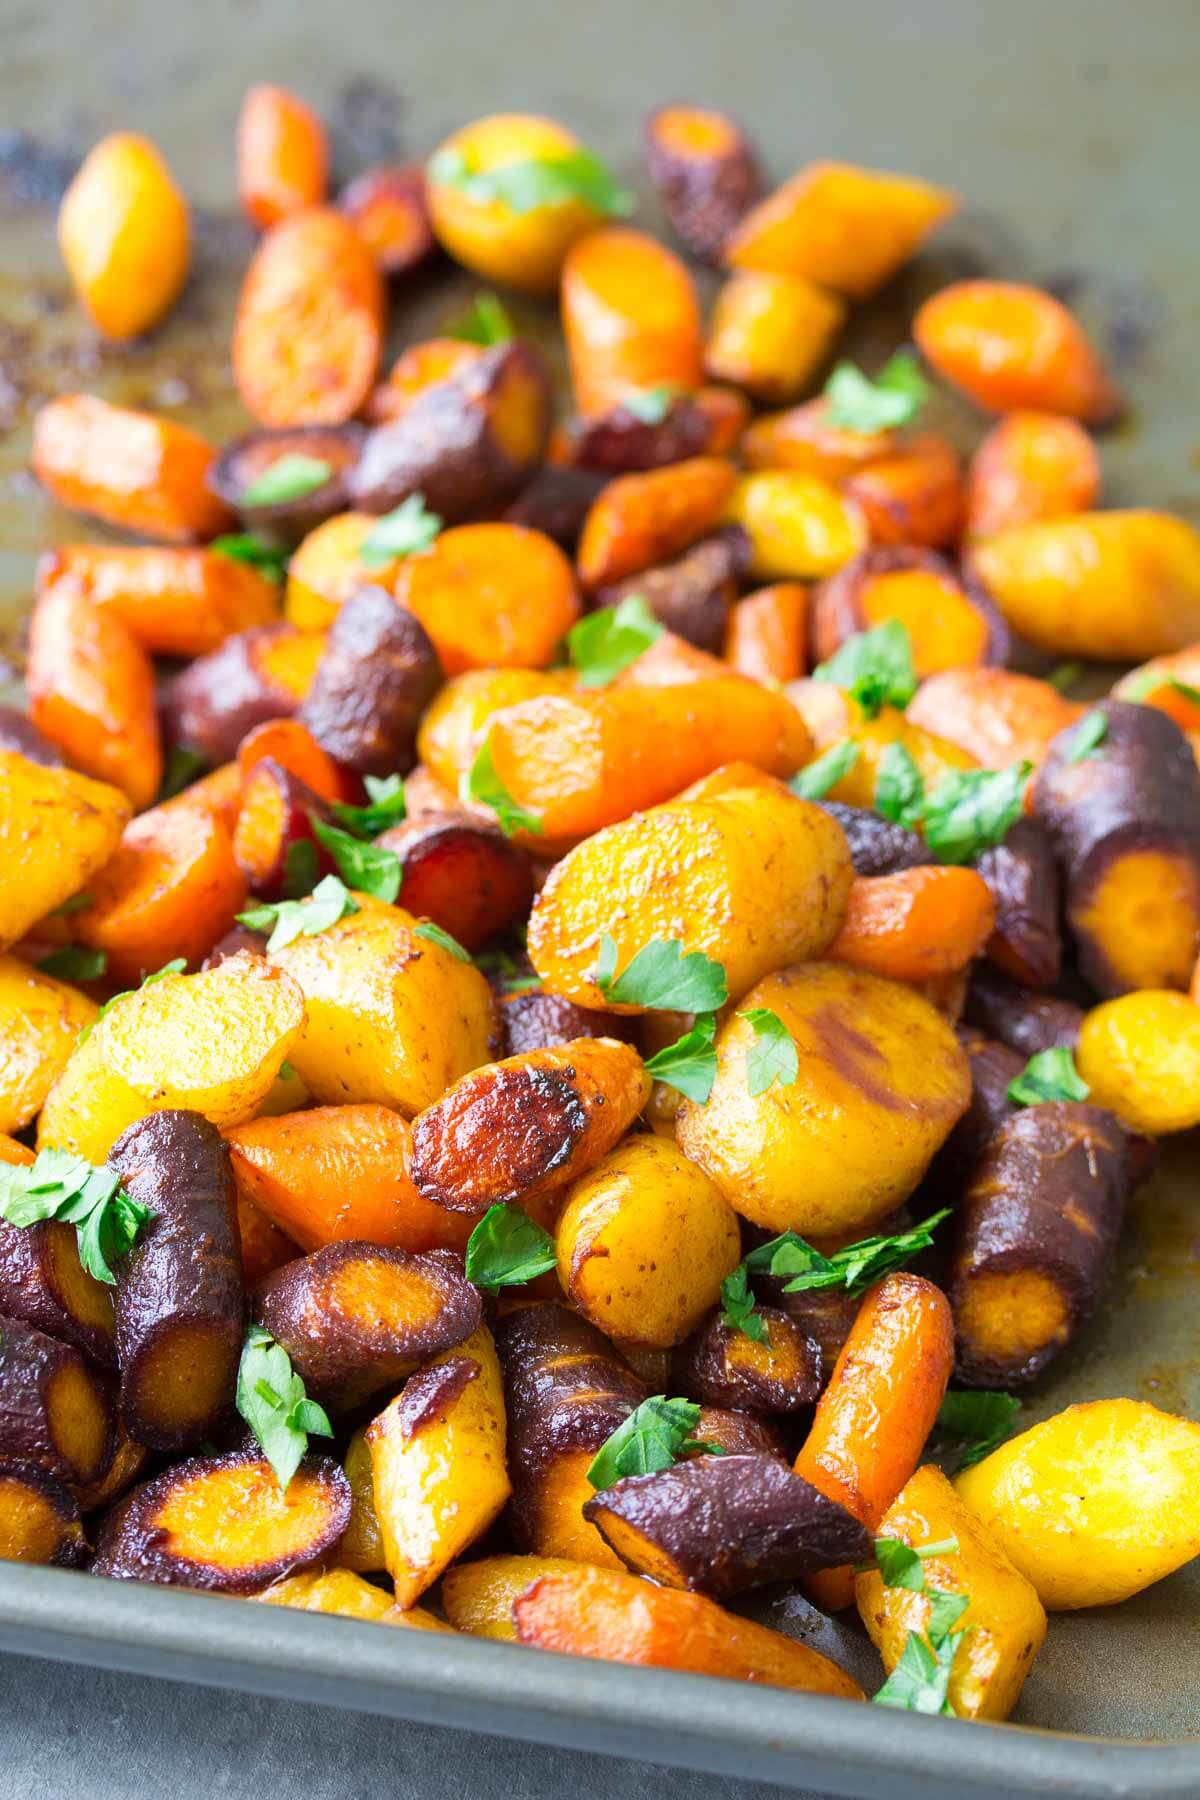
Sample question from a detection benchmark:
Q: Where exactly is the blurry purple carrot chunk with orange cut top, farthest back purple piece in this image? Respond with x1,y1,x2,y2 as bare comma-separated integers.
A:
646,106,763,263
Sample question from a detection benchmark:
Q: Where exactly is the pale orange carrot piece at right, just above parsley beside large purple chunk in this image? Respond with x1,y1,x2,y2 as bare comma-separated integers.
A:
905,666,1083,769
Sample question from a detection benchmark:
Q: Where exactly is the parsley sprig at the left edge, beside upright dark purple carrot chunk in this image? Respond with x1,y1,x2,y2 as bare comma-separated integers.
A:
0,1150,155,1287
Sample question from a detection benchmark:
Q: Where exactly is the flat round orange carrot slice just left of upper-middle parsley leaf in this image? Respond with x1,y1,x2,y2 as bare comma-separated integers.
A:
396,524,579,675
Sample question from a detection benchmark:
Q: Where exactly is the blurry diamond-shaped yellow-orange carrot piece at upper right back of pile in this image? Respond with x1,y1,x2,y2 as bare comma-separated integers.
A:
723,162,957,301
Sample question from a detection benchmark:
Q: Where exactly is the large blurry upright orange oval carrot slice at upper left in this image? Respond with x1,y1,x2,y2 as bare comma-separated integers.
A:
234,207,383,425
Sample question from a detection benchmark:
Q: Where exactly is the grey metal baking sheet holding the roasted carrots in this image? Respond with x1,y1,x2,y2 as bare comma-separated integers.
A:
0,0,1200,1800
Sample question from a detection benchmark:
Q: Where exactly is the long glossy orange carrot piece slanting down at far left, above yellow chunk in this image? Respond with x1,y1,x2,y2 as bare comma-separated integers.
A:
25,581,162,808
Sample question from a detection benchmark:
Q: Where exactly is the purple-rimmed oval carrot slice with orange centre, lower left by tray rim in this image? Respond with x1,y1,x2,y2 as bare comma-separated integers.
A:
92,1454,351,1593
